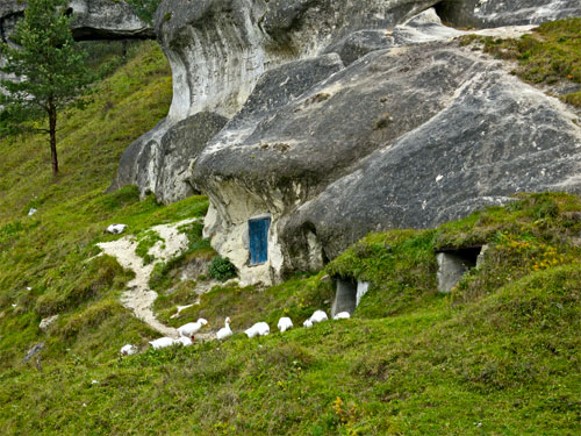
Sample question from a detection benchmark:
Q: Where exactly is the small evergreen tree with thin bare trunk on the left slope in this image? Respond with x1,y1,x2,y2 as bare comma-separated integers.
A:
0,0,91,176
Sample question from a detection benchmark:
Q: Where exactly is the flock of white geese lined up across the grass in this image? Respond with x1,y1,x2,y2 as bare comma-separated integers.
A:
121,310,351,356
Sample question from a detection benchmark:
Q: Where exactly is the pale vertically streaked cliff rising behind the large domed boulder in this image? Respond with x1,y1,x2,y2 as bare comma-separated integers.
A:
113,0,437,201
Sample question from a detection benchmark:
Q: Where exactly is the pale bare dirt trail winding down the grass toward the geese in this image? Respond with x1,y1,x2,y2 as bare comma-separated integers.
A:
97,219,196,338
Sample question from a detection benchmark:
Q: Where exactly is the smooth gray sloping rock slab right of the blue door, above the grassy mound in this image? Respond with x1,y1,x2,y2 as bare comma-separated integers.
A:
286,50,581,263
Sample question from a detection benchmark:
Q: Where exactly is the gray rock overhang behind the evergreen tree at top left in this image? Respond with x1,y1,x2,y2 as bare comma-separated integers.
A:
0,0,155,42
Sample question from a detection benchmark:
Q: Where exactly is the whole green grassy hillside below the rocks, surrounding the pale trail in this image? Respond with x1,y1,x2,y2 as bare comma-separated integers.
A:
0,24,581,434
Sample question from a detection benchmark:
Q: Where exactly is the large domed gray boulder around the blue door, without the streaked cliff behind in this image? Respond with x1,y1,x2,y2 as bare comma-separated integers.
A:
192,14,581,281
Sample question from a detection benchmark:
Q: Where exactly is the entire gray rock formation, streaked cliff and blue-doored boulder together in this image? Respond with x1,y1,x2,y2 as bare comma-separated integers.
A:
114,0,581,282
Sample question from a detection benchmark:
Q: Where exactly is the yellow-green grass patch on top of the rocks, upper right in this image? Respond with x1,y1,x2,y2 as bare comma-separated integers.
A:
460,18,581,107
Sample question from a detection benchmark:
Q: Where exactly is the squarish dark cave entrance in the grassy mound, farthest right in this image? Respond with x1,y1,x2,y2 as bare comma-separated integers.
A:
436,246,482,293
